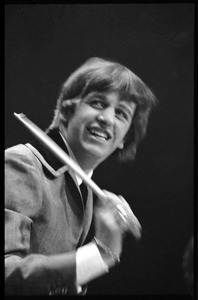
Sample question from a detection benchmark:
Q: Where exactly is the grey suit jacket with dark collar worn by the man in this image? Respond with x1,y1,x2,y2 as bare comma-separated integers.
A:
5,130,93,295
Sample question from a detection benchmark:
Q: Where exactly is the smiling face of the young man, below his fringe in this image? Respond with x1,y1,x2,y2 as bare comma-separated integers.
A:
66,92,136,167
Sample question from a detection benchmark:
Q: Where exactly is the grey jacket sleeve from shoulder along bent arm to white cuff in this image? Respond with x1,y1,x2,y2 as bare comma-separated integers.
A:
5,146,77,295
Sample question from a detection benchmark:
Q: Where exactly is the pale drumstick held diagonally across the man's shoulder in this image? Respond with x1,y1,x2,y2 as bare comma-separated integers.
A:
14,113,141,238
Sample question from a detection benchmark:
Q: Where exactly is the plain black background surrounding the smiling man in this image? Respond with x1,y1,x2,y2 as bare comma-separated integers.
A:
5,3,195,295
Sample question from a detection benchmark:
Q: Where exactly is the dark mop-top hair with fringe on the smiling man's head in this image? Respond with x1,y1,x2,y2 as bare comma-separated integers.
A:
49,57,156,161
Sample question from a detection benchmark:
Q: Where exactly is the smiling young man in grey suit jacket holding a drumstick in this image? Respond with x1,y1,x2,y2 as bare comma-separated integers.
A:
5,58,156,295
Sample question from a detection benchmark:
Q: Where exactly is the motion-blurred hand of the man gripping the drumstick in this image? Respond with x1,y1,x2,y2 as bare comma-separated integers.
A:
95,191,141,262
